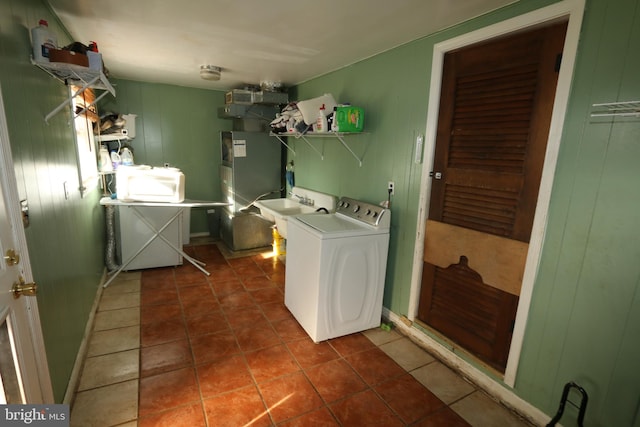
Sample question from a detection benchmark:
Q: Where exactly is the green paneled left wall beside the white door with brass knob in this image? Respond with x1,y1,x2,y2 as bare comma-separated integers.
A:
0,0,104,402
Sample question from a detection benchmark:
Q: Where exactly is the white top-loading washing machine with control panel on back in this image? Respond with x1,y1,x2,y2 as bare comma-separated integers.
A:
284,197,391,342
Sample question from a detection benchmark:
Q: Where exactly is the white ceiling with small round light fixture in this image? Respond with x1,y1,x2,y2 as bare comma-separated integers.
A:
49,0,517,90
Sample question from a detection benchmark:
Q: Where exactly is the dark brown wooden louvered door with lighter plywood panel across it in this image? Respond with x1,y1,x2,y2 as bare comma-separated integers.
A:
417,23,566,371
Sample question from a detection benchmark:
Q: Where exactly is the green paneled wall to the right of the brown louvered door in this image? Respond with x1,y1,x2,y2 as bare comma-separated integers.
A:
516,0,640,426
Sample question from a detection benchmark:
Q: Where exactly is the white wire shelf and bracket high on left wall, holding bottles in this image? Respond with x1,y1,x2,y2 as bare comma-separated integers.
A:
31,58,116,123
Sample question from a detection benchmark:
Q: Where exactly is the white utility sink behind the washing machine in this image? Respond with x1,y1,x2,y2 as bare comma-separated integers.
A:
254,187,337,239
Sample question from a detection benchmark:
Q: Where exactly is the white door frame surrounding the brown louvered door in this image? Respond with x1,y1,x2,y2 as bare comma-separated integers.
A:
407,0,585,387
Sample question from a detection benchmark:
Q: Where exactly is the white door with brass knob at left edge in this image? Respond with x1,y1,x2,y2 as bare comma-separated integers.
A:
0,84,53,404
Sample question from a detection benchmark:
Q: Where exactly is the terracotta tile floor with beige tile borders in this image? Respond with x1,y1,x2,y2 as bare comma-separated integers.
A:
71,244,527,427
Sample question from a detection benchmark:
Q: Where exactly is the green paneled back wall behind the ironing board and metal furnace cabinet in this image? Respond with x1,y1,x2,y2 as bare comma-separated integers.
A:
100,79,232,233
